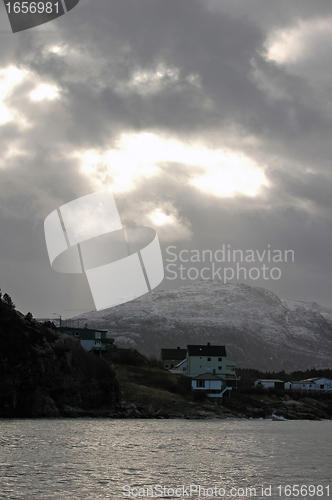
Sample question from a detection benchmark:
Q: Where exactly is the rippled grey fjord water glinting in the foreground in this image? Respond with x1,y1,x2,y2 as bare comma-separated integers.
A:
0,419,332,500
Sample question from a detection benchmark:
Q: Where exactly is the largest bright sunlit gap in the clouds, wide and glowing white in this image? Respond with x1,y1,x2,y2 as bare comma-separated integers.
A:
74,133,267,196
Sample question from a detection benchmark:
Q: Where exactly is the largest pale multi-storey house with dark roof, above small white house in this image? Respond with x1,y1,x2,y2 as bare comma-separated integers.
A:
186,342,237,381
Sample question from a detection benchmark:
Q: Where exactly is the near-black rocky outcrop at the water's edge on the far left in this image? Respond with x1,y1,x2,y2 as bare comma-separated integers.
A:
0,300,119,417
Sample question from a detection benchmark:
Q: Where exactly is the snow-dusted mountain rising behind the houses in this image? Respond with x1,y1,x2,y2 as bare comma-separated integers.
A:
68,280,332,371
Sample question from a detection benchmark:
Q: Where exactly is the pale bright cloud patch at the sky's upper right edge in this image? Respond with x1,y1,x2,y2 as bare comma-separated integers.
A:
265,18,332,64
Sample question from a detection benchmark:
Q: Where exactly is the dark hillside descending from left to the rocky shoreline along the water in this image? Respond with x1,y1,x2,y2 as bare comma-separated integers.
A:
0,288,332,420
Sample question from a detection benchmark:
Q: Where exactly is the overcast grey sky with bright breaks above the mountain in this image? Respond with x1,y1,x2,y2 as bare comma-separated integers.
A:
0,0,332,317
